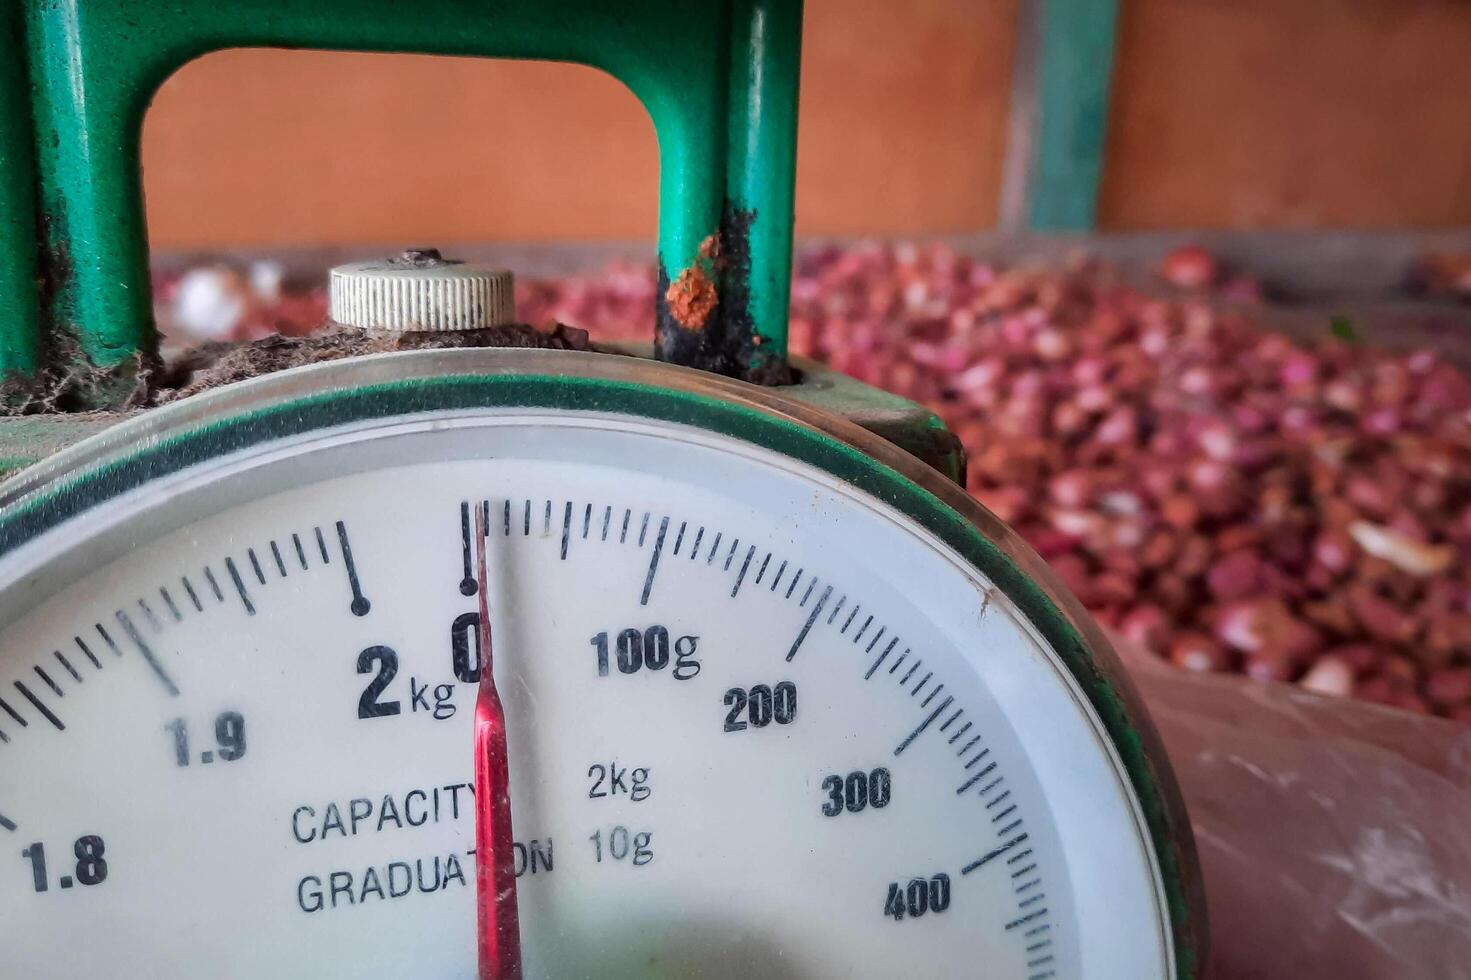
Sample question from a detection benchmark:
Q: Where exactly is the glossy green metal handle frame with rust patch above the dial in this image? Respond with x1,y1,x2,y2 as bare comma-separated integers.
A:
0,0,802,408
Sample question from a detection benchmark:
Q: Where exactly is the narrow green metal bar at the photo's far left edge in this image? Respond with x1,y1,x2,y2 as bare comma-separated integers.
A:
0,0,41,377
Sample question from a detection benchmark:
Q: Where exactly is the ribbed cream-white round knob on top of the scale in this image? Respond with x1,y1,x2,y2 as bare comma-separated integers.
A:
327,249,516,333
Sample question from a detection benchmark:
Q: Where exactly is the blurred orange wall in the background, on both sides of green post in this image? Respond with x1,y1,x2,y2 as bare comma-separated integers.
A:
143,0,1471,247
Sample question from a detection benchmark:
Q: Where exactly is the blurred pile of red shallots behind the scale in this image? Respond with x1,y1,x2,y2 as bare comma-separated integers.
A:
158,244,1471,722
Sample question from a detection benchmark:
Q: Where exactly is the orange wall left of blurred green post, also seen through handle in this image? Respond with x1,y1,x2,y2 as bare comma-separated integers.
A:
143,0,1016,247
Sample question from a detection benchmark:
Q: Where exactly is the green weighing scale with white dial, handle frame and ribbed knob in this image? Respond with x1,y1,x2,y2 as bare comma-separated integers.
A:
0,0,1205,980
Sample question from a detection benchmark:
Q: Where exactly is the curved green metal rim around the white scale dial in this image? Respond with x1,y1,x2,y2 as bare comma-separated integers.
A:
0,352,1208,980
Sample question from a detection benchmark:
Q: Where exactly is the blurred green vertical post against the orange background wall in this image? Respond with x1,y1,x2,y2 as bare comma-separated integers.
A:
1025,0,1118,231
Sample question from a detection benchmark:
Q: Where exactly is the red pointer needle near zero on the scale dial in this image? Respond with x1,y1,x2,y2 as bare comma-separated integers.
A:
475,506,521,980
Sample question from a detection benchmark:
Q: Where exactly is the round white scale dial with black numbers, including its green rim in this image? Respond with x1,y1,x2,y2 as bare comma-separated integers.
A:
0,352,1194,980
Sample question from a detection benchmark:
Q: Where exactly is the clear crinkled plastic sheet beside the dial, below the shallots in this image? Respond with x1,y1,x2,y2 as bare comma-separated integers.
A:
1118,643,1471,980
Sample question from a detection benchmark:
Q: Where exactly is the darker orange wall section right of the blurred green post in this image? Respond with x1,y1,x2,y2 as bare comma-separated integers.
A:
1100,0,1471,228
